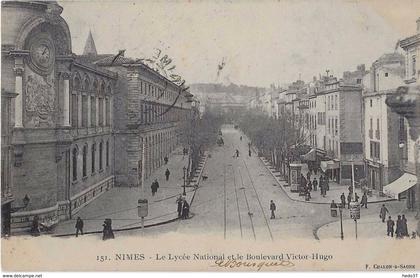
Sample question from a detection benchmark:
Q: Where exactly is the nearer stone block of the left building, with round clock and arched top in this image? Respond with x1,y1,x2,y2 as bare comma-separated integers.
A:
2,1,117,230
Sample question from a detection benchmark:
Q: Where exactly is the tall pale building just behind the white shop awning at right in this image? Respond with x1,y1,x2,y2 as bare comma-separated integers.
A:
363,53,407,192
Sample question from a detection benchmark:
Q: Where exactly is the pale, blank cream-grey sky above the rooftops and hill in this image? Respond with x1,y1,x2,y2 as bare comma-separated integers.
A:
59,0,420,87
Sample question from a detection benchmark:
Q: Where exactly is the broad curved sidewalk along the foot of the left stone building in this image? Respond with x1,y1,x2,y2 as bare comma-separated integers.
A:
54,148,205,236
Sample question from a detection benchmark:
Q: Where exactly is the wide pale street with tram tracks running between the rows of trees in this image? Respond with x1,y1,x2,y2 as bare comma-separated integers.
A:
130,127,404,240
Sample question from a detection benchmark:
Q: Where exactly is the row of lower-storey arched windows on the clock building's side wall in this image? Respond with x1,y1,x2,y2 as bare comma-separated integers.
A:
72,141,109,181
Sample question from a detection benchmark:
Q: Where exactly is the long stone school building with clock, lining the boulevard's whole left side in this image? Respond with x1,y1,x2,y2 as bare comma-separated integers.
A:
1,1,191,234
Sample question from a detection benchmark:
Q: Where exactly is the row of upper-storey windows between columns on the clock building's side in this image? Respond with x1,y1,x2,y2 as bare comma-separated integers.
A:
71,93,111,127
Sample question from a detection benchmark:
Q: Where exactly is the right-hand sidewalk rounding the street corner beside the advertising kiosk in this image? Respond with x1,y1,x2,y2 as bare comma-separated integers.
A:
254,155,396,204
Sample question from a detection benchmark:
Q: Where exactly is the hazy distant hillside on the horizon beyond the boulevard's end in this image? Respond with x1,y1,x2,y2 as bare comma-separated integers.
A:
189,83,266,97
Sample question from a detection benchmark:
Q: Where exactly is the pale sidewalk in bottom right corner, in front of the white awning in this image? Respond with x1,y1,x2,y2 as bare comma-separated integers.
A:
316,205,420,240
